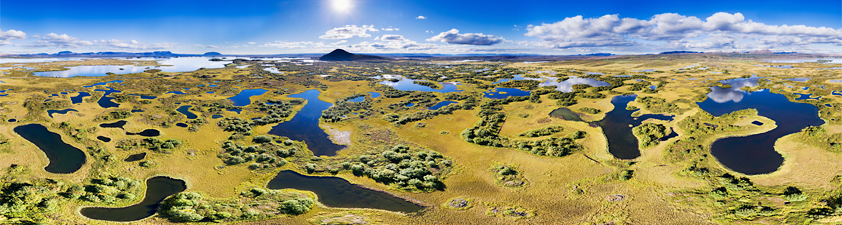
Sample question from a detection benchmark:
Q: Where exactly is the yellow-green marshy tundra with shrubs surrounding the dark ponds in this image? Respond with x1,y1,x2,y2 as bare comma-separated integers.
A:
0,53,842,224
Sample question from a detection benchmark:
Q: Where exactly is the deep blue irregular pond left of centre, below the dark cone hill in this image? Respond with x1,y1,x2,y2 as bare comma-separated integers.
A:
269,90,345,156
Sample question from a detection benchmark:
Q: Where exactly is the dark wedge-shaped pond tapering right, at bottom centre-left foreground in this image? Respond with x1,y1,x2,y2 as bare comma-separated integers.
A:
266,170,424,213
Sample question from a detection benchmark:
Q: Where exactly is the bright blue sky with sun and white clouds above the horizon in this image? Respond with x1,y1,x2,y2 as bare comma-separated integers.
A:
0,0,842,55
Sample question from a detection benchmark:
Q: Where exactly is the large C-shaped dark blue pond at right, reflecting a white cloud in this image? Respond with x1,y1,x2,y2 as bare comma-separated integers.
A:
698,84,824,175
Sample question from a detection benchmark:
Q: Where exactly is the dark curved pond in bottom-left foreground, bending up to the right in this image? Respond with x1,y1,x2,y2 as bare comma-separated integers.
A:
79,177,187,222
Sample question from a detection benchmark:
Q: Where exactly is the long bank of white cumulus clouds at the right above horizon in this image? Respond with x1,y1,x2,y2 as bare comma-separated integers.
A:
525,12,842,49
